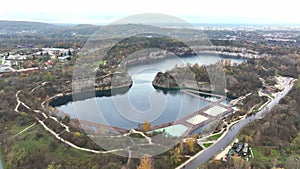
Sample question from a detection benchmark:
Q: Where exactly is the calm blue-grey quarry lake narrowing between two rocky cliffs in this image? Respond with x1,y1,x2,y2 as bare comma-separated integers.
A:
56,54,245,129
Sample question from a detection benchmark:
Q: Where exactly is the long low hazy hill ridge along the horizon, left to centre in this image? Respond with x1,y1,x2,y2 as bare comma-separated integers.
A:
0,20,205,37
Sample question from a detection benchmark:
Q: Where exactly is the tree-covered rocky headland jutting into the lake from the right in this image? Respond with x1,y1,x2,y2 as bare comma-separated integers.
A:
152,55,300,98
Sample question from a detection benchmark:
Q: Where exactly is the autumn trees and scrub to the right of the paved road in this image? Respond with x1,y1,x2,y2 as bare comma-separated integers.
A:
201,56,300,169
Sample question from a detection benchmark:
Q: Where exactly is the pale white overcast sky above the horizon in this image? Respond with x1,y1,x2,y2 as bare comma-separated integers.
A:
0,0,300,24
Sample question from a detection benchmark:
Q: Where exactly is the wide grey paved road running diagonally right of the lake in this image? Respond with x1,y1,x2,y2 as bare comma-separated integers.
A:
182,79,293,169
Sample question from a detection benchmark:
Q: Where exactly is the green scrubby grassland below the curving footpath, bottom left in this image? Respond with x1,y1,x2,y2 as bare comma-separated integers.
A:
0,125,126,168
